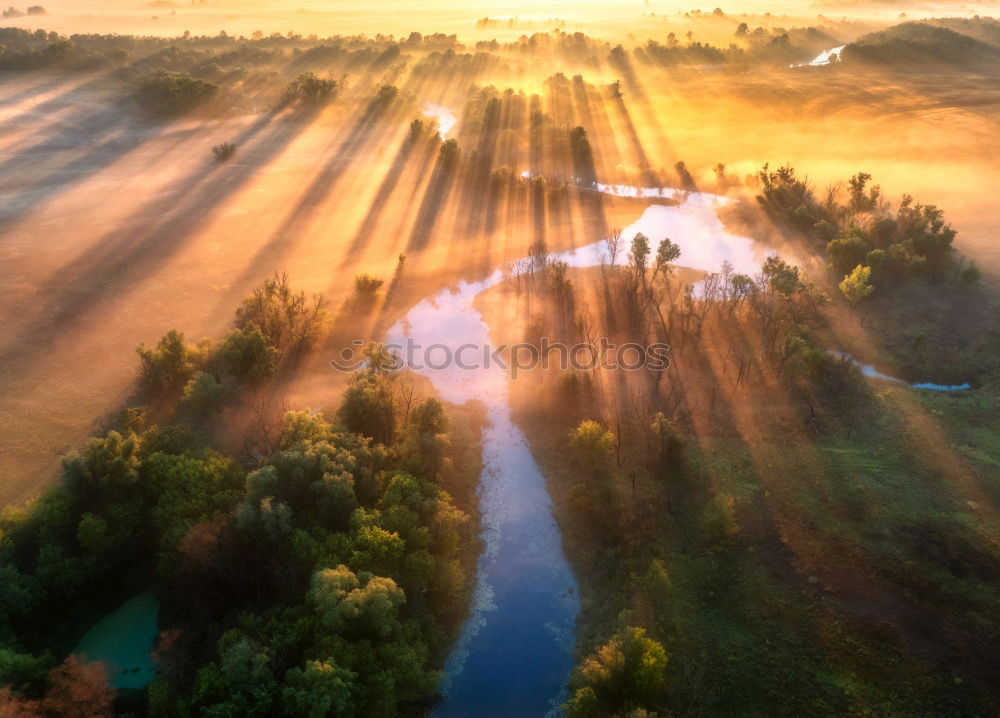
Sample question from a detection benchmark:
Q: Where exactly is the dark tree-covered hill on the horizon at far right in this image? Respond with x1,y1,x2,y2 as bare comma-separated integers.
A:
841,22,1000,65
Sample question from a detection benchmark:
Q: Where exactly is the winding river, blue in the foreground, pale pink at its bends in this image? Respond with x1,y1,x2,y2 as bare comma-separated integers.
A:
386,185,766,717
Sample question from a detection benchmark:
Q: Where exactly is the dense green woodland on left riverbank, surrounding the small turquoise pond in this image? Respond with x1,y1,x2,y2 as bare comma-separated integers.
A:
0,286,477,716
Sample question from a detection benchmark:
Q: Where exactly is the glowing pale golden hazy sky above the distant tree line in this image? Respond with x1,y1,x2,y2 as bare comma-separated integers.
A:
3,0,971,39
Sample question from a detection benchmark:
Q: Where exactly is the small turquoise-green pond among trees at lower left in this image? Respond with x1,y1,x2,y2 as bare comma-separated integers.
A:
73,592,160,690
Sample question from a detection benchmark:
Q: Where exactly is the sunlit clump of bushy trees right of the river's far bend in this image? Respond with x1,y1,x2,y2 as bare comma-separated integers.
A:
757,167,1000,384
